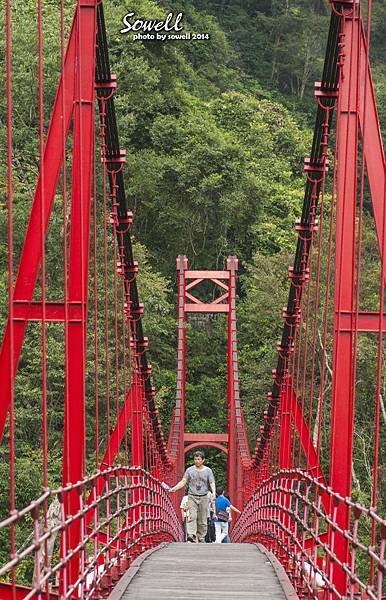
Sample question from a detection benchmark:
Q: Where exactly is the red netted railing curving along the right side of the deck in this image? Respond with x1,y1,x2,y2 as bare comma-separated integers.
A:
232,469,386,600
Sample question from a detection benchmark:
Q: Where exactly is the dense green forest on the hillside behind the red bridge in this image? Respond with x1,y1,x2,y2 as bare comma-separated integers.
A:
0,0,386,548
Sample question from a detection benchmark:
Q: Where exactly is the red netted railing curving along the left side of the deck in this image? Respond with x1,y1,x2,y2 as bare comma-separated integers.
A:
0,466,182,600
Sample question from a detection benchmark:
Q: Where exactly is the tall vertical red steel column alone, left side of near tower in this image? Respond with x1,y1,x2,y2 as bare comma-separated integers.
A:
62,0,97,584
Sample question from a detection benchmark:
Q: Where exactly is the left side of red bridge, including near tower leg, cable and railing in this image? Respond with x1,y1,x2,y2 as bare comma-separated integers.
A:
0,0,175,597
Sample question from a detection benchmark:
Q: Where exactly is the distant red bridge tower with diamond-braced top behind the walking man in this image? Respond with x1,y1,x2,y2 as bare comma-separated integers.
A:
168,256,250,506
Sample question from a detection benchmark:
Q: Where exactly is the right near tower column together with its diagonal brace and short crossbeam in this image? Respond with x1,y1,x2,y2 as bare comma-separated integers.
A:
330,12,386,594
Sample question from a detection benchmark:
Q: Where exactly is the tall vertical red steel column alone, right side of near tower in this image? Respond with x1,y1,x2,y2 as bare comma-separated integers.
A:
330,15,362,596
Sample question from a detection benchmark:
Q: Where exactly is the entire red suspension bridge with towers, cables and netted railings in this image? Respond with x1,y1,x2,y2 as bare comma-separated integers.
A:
0,0,386,599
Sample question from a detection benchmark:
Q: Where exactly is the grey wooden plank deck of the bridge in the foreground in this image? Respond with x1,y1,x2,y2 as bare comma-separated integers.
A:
109,543,297,600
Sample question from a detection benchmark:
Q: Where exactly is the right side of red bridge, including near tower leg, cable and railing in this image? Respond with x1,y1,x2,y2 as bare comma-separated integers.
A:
243,0,386,598
